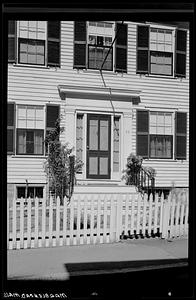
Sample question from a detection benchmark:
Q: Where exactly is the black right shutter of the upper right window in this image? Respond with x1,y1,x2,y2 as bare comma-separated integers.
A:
175,30,187,77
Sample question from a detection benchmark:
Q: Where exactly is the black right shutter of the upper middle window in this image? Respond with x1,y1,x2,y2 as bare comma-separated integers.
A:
115,23,127,72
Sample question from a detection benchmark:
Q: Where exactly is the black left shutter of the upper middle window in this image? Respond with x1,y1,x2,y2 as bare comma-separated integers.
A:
73,21,86,69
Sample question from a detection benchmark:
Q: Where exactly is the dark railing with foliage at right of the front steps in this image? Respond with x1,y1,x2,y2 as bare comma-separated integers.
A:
127,167,155,195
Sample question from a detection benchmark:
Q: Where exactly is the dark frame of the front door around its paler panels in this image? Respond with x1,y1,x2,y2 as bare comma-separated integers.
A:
86,113,111,179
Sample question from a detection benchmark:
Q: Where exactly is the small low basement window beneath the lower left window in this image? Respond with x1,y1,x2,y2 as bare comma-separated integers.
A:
17,186,43,199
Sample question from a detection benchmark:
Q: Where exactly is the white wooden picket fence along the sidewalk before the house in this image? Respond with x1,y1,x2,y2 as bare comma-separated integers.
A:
7,193,188,249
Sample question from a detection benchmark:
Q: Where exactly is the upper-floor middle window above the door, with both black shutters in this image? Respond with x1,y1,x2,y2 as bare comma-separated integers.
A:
74,22,127,72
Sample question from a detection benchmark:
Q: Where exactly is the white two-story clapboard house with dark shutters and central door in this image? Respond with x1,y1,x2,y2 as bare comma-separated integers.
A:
7,20,189,204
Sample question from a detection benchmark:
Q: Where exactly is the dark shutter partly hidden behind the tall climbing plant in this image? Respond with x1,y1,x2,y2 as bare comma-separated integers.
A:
45,105,60,154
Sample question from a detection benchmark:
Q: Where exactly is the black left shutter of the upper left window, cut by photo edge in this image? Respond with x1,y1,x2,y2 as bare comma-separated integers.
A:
8,20,16,62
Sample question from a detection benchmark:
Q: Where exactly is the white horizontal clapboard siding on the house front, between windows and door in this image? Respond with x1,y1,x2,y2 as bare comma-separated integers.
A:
8,21,189,186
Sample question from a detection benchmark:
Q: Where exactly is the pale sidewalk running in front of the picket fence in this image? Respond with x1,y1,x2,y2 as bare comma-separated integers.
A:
7,238,188,280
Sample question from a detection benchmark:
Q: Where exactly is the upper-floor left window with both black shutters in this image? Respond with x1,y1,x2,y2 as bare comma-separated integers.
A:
8,21,60,66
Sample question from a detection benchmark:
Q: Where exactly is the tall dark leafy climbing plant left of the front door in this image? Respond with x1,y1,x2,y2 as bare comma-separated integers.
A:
45,118,83,201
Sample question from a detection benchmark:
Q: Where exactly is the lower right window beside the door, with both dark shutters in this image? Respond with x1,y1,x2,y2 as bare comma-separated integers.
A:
137,110,187,159
